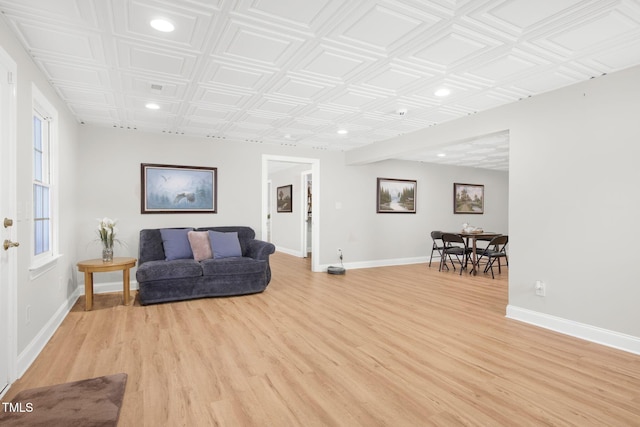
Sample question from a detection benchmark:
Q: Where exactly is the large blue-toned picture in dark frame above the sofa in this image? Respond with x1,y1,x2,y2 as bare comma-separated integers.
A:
140,163,218,214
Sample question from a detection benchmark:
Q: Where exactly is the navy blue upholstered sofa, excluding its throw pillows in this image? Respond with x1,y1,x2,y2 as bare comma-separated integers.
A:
136,227,275,305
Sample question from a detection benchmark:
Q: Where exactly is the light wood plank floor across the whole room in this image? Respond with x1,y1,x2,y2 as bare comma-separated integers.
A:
3,253,640,427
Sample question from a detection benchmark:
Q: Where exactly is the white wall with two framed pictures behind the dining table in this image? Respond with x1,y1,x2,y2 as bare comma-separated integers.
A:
321,160,508,267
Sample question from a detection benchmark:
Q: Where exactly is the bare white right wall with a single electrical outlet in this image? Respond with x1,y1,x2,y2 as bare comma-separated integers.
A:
509,67,640,340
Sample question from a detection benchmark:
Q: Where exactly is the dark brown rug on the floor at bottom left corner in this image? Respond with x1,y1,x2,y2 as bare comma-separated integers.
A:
0,373,127,427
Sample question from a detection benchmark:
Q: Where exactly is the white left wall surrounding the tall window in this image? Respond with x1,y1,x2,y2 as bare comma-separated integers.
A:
0,19,79,368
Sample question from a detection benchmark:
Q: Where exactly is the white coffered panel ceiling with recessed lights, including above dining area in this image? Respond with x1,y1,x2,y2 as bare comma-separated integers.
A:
0,0,640,170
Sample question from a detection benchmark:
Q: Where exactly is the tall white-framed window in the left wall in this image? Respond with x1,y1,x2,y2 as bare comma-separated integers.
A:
30,86,59,277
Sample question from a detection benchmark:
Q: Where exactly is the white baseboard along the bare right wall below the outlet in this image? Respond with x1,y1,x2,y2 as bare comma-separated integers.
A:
507,305,640,355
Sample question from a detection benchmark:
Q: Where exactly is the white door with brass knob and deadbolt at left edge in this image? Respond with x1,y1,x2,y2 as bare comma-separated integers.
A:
0,49,18,396
